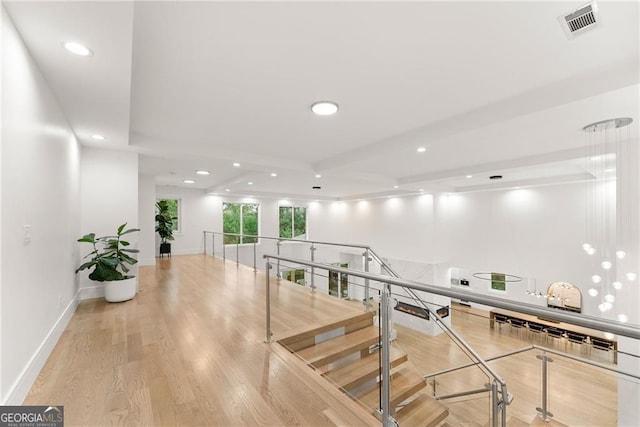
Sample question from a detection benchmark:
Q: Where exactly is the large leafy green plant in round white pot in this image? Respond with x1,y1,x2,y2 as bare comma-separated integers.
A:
76,222,140,302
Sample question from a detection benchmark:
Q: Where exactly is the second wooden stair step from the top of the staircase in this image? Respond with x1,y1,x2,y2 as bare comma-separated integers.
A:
297,326,379,367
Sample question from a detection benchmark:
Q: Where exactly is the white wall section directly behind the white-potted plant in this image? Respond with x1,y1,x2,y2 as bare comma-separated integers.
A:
78,147,139,299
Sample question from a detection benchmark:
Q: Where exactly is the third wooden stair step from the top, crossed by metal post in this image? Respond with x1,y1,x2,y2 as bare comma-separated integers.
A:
325,347,408,391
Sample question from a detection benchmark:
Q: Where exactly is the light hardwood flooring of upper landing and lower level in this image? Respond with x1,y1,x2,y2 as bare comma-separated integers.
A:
24,255,617,426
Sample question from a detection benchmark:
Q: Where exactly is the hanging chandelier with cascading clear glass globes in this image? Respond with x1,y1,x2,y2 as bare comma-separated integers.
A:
582,117,638,321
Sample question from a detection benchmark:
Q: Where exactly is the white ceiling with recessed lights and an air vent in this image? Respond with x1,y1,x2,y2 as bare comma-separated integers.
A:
3,1,640,199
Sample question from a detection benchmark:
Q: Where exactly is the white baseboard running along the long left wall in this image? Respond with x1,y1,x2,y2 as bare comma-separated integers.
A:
0,292,80,405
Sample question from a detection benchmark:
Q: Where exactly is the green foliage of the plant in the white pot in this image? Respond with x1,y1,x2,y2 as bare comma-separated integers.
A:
76,222,140,282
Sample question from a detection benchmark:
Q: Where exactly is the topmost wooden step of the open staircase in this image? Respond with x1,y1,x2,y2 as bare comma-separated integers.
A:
277,311,375,351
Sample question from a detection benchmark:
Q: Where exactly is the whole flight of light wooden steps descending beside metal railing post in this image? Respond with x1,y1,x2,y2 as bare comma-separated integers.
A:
278,312,449,427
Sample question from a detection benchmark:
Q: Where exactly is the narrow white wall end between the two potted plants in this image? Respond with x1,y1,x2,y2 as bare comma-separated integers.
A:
138,175,156,266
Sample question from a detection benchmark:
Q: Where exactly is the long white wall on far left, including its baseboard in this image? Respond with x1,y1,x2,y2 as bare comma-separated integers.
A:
0,7,80,404
